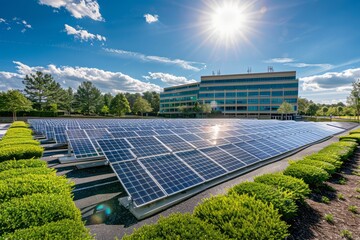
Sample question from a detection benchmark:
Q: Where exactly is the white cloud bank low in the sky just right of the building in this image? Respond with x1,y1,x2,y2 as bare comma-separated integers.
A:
300,68,360,92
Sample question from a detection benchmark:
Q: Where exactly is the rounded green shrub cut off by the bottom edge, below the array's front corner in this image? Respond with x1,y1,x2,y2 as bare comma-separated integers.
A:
123,213,227,240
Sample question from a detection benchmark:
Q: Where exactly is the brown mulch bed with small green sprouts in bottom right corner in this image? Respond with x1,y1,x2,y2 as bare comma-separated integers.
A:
288,149,360,240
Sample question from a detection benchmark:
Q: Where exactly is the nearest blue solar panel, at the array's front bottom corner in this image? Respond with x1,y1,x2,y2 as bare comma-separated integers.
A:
111,161,166,207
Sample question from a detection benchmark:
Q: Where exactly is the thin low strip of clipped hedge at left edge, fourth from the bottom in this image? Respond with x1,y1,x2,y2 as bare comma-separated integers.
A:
0,167,56,180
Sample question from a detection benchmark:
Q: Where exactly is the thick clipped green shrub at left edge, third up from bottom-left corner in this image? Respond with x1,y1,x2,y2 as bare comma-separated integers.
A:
0,174,73,203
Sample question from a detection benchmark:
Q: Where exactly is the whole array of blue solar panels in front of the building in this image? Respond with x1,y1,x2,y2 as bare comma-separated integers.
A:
31,119,344,207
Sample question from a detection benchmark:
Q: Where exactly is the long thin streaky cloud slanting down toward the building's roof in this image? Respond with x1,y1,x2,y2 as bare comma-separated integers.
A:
104,48,206,71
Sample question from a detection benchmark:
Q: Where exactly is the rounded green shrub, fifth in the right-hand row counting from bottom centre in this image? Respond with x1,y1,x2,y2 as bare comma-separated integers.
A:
284,164,330,185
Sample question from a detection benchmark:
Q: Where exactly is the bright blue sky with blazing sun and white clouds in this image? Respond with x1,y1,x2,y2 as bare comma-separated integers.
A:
0,0,360,103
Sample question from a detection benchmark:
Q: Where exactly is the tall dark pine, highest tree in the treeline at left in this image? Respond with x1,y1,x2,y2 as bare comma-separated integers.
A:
22,71,61,110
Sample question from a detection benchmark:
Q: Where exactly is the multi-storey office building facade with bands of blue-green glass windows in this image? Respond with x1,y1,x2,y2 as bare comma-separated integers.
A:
160,71,299,116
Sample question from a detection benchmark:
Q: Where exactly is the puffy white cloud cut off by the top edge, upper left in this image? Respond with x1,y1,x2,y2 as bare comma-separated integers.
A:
39,0,104,21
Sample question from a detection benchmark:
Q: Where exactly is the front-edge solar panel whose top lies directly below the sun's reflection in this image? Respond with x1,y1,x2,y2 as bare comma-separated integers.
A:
200,147,245,172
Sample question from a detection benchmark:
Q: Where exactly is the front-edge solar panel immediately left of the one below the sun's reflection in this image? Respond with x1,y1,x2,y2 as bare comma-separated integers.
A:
175,150,227,180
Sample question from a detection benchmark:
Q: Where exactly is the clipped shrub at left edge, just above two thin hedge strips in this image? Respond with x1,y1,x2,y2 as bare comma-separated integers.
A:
0,145,44,162
